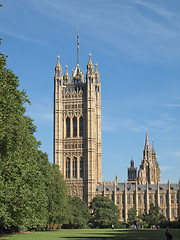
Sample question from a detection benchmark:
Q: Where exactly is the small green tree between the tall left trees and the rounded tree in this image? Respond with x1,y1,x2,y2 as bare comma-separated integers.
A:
62,196,91,228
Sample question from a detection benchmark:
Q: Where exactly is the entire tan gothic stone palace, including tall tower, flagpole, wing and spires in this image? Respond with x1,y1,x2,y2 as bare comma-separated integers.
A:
54,31,180,222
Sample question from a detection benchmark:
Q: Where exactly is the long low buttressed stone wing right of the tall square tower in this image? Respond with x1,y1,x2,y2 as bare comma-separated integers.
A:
96,178,180,222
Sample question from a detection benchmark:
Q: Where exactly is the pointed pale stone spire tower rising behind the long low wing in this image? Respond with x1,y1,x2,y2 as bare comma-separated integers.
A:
138,131,161,184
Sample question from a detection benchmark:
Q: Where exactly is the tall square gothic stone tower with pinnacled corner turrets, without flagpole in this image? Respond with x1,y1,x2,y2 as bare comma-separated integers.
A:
54,44,101,203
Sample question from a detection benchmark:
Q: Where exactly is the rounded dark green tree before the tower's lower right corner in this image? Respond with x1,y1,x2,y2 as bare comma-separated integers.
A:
90,196,119,228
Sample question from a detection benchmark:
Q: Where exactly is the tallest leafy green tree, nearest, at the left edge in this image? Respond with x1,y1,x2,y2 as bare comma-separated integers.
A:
0,48,47,231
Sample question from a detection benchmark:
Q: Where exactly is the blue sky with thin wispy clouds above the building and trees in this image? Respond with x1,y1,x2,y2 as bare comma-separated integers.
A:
0,0,180,183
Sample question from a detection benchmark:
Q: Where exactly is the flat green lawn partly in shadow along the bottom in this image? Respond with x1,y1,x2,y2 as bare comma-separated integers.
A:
1,229,180,240
